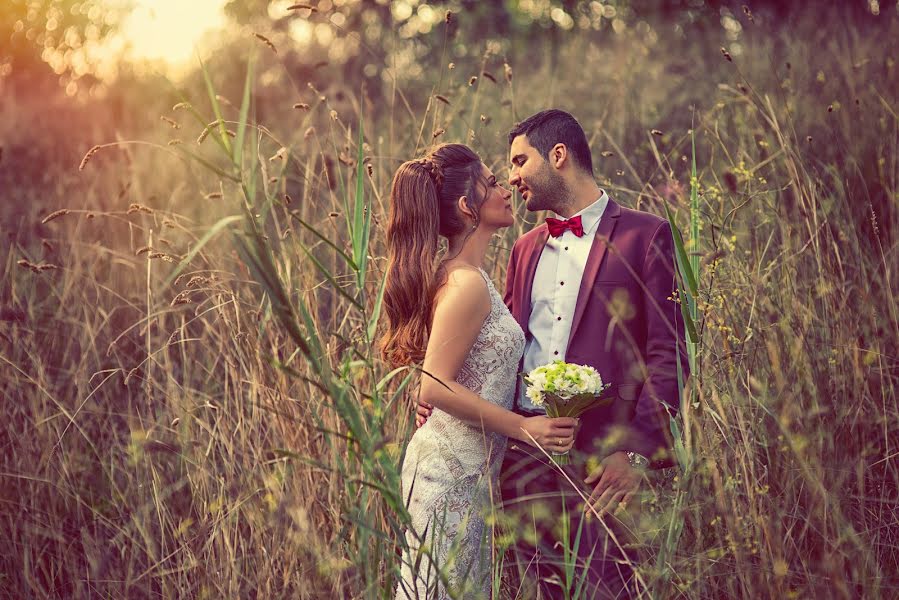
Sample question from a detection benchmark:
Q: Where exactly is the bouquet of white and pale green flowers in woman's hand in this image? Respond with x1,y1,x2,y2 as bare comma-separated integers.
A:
524,360,609,465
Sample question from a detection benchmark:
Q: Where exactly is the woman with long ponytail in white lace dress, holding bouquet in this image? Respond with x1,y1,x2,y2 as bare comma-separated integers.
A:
381,144,577,599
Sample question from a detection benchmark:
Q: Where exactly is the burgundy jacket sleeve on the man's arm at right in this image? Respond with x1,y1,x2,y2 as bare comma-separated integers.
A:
619,222,689,467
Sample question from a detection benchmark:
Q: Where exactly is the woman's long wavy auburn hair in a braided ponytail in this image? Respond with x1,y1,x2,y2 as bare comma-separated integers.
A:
380,144,484,366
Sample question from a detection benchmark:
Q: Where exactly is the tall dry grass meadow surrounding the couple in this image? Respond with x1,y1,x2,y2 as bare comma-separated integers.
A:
0,2,899,600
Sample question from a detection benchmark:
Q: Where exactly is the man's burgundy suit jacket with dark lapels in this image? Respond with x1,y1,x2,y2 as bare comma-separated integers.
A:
505,200,688,467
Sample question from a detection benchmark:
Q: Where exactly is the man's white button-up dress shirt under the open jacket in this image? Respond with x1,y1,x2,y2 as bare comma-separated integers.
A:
518,192,609,412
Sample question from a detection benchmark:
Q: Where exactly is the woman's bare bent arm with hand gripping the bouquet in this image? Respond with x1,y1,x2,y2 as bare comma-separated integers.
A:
419,269,577,451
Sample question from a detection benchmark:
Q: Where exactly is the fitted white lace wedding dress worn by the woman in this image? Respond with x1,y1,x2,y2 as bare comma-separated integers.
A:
396,270,524,600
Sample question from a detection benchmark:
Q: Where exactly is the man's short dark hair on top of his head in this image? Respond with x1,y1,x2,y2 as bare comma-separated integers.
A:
509,108,593,176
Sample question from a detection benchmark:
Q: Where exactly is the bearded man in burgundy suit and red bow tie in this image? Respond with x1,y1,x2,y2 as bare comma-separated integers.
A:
419,109,687,598
